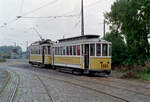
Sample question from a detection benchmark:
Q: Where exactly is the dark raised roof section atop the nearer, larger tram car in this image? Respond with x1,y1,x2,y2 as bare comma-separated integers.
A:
58,35,100,42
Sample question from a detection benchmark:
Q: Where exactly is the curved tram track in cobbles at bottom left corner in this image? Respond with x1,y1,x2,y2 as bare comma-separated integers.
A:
0,72,20,102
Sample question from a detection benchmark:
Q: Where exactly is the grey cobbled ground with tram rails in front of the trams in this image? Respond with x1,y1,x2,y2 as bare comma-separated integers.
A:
0,60,150,102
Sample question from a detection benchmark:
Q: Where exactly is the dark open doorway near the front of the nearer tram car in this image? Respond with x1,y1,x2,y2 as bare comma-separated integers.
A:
84,44,89,70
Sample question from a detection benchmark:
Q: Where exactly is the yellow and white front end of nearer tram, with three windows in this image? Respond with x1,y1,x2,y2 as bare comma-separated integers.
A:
89,43,111,74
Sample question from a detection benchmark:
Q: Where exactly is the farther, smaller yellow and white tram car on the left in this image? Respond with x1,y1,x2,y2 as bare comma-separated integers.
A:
29,39,53,67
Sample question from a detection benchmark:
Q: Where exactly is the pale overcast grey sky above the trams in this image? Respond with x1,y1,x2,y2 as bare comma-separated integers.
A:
0,0,115,50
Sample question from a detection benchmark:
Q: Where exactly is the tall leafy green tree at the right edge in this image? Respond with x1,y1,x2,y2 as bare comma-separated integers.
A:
105,0,150,65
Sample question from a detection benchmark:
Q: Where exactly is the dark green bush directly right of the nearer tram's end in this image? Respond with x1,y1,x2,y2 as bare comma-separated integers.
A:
104,32,128,66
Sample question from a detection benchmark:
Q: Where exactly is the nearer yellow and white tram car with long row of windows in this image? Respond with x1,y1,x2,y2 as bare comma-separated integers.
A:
52,35,111,75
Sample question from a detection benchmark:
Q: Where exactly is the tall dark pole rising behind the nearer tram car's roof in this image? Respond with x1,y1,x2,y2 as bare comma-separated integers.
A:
81,0,84,36
